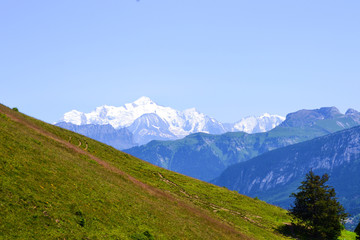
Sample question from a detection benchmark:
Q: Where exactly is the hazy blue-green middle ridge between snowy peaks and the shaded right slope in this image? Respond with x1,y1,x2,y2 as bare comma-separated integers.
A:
125,107,360,181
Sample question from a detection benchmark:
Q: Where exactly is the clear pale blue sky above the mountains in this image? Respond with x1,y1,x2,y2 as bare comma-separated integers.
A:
0,0,360,122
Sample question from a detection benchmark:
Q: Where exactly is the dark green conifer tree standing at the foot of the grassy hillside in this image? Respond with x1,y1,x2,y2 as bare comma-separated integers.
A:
289,171,348,240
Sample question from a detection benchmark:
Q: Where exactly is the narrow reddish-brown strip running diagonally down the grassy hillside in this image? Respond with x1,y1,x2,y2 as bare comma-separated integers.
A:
0,106,251,239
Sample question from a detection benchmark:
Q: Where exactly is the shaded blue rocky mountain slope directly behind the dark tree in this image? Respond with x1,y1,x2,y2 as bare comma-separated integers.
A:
214,126,360,230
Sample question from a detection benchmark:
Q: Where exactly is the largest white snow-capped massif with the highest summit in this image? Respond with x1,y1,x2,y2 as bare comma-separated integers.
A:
60,97,225,138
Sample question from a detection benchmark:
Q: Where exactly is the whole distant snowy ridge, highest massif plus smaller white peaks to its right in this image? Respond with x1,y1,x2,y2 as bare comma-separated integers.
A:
56,97,285,149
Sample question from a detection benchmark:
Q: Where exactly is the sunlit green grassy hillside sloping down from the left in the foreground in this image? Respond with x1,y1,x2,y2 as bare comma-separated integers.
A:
0,105,353,239
